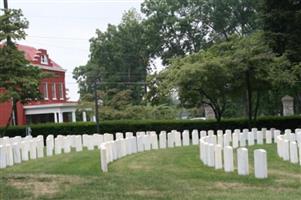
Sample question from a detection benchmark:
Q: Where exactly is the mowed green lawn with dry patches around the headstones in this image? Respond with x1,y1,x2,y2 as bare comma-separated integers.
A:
0,145,301,200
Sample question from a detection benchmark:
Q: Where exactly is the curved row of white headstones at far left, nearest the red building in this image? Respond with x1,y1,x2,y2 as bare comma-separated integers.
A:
0,134,113,169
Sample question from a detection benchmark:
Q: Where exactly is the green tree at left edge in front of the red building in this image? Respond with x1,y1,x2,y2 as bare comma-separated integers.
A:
0,9,42,131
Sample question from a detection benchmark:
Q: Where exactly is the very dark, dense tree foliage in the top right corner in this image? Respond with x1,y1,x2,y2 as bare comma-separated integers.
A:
263,0,301,63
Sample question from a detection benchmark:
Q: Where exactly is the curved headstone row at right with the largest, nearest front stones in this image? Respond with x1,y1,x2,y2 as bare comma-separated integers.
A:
199,128,281,179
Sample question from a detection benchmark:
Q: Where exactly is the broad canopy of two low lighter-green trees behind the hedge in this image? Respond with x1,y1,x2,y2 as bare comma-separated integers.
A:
161,32,294,120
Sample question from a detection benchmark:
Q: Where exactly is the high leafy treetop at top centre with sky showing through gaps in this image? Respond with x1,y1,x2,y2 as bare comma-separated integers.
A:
141,0,260,63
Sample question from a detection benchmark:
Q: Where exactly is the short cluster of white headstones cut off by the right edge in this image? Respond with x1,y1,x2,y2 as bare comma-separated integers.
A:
276,129,301,165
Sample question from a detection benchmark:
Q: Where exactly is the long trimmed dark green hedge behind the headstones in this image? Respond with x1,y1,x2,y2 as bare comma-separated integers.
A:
0,116,301,137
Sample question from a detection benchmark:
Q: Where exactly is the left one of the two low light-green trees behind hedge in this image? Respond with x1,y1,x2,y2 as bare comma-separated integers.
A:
161,41,234,122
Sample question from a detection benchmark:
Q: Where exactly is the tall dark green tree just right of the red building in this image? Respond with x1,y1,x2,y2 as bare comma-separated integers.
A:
73,10,149,104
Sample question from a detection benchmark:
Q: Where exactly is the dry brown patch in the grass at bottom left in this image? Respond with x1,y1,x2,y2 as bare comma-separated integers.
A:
7,174,85,198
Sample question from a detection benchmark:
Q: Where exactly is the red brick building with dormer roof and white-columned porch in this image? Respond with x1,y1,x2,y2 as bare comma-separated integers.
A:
0,44,86,126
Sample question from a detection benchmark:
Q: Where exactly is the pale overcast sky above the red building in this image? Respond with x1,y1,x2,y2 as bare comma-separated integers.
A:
0,0,148,101
